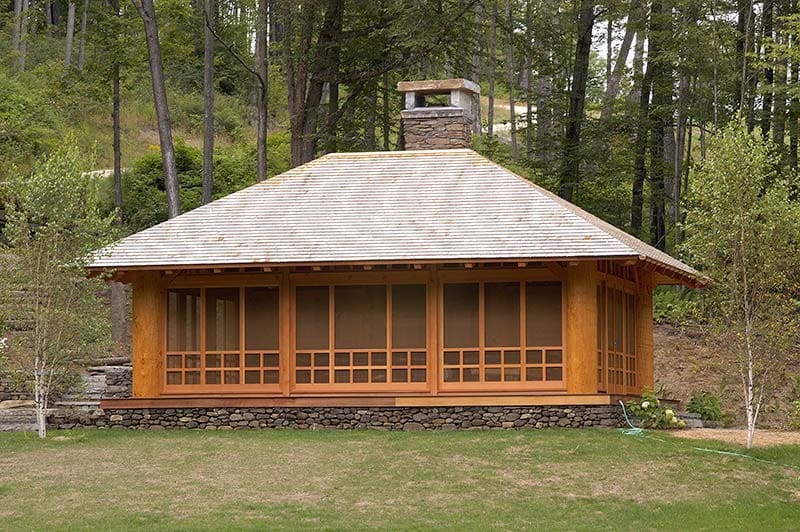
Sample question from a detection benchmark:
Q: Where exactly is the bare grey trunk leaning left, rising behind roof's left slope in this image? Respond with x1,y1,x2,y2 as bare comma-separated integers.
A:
131,0,181,218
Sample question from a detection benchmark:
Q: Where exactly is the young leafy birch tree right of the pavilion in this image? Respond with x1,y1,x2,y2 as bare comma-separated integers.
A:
686,122,800,440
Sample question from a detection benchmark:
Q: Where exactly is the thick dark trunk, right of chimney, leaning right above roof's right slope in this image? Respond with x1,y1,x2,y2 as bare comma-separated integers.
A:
558,0,595,201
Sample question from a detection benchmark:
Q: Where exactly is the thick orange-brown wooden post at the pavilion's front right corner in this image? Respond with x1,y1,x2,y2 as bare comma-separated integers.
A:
565,261,597,394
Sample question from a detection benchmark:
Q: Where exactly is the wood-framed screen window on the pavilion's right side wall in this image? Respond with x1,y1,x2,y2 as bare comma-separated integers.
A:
597,280,641,394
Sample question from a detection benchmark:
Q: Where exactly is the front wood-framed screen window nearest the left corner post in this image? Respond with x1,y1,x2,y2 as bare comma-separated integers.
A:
165,286,280,393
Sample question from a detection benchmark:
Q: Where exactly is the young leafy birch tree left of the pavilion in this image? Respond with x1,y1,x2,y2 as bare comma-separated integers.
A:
0,139,115,428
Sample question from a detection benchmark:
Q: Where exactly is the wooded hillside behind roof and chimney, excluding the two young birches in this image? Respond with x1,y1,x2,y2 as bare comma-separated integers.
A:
0,0,800,248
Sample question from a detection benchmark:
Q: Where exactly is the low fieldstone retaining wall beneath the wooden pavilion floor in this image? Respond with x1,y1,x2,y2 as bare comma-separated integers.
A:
49,406,622,431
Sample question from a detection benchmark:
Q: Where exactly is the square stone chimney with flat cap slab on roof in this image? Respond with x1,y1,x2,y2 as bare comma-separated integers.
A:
397,79,481,150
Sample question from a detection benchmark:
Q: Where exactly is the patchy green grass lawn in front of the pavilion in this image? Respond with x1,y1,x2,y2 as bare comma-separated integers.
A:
0,429,800,530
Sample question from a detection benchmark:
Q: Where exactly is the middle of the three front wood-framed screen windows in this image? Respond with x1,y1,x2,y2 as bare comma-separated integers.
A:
293,284,428,393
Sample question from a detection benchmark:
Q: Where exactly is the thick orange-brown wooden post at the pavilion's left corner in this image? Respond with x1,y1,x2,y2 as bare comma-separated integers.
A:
131,272,166,397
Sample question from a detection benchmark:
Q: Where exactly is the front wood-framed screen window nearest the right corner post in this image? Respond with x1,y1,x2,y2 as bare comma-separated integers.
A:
441,281,564,391
